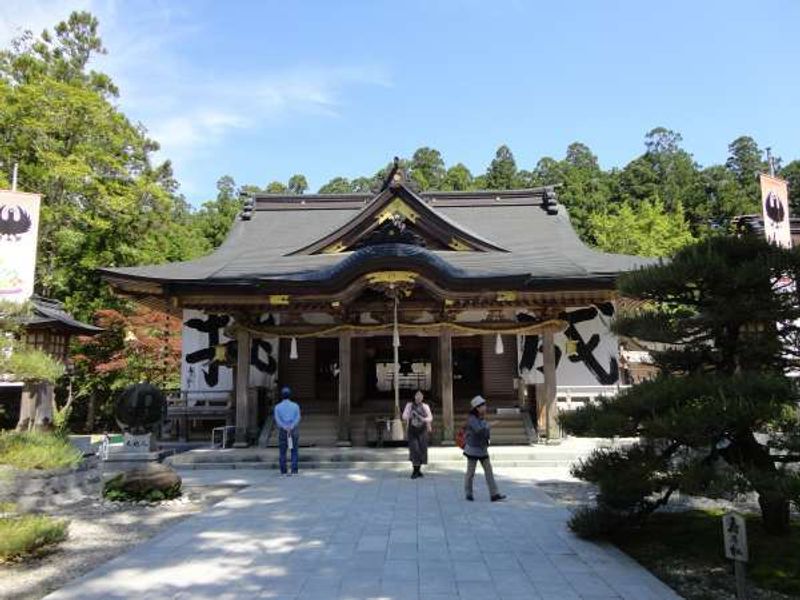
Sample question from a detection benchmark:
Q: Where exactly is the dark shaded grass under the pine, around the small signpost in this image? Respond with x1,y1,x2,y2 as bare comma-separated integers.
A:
611,511,800,598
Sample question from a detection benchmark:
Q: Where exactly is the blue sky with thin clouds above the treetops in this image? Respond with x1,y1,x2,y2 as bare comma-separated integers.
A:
0,0,800,204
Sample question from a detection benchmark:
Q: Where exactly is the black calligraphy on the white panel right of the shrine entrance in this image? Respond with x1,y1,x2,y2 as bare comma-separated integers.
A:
517,302,619,385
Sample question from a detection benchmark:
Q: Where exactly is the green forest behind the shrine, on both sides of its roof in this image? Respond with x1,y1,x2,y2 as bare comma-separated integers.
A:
0,12,800,319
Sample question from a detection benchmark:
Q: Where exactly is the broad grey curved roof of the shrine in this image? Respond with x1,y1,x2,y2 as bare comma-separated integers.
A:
100,185,653,293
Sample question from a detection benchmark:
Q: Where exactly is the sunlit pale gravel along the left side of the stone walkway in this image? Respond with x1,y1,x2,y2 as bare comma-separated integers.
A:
0,486,241,600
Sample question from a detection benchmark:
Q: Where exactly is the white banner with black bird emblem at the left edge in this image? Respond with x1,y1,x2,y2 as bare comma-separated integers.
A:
0,190,40,302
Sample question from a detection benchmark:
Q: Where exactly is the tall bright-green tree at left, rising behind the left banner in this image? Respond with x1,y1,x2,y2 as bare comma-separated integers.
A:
0,13,205,318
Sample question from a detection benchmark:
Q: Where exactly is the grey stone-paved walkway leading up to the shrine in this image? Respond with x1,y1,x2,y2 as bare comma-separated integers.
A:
47,469,678,600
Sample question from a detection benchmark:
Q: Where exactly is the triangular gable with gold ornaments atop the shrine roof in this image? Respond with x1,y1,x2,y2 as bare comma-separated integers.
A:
291,164,507,255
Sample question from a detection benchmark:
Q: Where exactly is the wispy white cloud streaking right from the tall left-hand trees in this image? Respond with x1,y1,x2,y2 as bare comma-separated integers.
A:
0,0,390,190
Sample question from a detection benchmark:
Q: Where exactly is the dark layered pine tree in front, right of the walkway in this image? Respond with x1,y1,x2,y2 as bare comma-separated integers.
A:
562,236,800,534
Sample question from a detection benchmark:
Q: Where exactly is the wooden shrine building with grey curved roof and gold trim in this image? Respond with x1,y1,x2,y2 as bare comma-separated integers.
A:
102,167,650,445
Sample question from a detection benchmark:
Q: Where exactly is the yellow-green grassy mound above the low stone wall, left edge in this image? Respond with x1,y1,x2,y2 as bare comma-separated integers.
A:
0,431,82,469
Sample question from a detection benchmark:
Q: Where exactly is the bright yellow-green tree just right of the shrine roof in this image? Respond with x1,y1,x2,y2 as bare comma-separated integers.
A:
589,200,694,256
